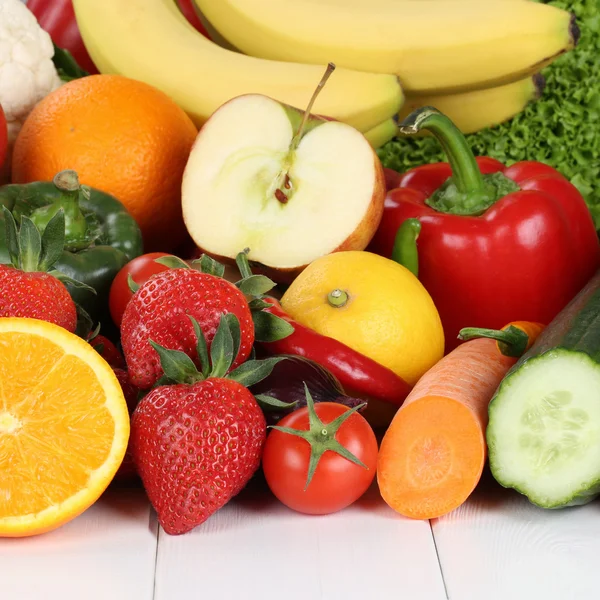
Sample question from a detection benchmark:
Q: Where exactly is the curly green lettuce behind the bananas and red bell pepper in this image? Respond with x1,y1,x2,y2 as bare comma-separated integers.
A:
378,0,600,229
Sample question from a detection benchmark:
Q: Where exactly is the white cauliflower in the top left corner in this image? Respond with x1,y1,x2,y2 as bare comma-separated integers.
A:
0,0,63,150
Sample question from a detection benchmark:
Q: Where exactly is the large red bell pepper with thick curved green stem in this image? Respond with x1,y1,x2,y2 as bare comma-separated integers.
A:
368,107,600,351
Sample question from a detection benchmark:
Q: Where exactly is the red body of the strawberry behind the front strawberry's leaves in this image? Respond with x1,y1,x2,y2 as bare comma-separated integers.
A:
121,268,254,389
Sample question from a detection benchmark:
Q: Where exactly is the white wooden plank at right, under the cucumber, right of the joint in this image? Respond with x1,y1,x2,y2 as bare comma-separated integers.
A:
432,475,600,600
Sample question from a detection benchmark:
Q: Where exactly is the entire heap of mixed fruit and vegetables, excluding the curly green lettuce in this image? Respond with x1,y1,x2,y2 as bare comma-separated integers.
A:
0,0,600,536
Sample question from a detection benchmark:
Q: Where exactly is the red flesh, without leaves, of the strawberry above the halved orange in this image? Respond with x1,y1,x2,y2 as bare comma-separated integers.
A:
0,265,77,333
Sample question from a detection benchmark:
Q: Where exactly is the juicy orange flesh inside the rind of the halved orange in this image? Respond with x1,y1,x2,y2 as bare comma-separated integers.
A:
0,332,115,535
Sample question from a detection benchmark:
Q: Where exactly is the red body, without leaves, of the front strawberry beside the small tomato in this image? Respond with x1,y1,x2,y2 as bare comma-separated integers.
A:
130,378,266,535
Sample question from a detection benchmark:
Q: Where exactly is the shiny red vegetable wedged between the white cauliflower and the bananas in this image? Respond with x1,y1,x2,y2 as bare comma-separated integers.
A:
27,0,98,75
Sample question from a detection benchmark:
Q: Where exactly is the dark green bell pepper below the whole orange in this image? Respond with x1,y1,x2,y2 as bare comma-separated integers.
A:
0,170,143,321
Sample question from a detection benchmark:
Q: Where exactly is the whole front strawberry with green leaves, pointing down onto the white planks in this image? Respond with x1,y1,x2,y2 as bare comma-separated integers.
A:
130,316,283,535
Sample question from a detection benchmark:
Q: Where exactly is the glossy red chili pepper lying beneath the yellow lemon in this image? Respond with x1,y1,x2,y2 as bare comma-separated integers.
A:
260,298,411,406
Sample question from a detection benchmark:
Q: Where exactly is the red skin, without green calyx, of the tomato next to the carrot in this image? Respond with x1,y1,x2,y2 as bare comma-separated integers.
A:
262,402,378,515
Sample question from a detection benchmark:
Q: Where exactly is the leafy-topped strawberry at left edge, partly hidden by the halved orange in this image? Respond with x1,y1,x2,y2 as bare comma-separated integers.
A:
0,207,93,333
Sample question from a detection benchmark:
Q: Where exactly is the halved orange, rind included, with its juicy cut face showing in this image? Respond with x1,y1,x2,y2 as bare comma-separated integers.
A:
0,318,129,537
